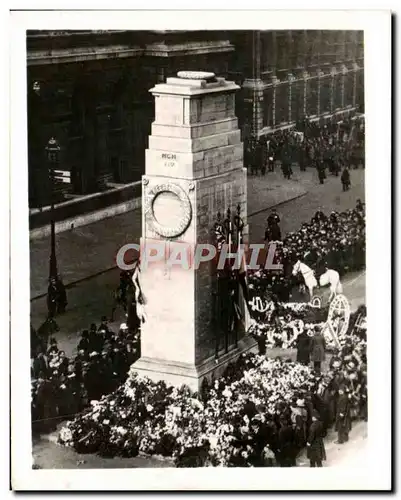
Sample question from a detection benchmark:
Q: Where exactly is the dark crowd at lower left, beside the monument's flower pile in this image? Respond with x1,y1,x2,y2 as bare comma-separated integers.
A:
31,317,140,432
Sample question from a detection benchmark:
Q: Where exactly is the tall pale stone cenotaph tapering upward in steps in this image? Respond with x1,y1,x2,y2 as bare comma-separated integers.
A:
134,71,255,391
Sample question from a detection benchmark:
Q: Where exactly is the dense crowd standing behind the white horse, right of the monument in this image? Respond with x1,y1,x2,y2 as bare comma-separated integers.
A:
253,200,366,302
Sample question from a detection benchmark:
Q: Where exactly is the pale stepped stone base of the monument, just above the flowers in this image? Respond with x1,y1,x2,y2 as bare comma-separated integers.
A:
132,336,256,392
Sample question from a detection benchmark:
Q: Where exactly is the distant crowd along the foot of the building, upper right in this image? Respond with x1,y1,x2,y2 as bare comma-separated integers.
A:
247,118,365,190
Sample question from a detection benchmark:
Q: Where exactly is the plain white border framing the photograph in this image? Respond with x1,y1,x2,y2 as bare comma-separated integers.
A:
10,10,392,491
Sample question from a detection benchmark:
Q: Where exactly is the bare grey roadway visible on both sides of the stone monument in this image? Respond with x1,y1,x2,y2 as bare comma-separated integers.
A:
31,170,365,356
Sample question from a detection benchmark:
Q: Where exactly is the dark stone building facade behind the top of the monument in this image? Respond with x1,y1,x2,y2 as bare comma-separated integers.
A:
27,30,364,207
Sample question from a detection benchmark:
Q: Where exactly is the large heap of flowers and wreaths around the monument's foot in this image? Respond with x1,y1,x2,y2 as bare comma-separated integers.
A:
59,355,316,466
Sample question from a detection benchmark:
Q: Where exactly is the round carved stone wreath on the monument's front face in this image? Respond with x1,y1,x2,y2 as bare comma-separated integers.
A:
145,183,192,238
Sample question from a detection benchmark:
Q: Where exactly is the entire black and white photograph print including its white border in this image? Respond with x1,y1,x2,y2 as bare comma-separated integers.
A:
10,7,391,490
